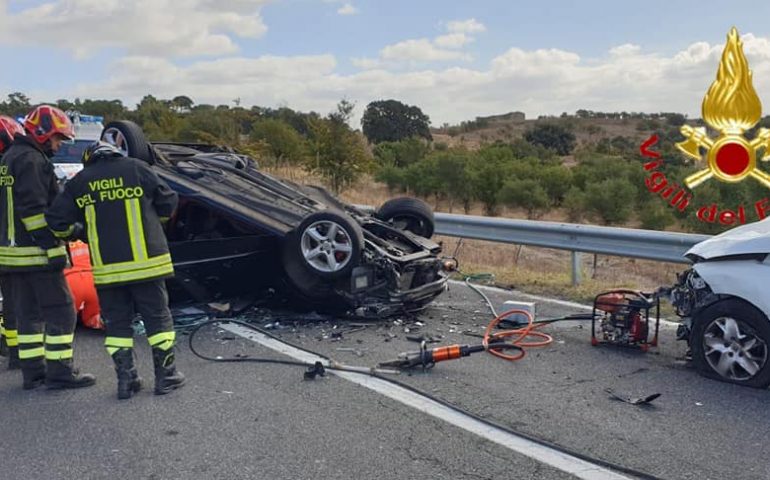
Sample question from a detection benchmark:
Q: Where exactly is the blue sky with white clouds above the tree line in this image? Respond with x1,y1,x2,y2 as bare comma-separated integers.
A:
0,0,770,126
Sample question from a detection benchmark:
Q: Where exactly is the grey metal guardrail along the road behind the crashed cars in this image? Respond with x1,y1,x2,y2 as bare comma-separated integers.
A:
360,206,711,285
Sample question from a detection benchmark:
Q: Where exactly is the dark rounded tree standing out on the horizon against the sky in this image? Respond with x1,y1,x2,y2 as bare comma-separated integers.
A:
361,100,433,143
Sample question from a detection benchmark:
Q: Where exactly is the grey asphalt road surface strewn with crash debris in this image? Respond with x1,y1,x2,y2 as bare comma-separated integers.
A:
0,284,770,480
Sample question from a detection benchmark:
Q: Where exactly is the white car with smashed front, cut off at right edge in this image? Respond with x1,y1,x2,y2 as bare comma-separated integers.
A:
671,218,770,388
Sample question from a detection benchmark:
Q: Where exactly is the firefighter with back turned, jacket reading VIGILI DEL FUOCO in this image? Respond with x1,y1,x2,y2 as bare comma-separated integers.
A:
46,142,185,400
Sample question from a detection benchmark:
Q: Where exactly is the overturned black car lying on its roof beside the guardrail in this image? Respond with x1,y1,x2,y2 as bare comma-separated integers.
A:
71,121,448,317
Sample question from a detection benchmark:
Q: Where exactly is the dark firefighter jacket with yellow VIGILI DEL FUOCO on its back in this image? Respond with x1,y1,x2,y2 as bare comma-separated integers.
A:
46,156,177,287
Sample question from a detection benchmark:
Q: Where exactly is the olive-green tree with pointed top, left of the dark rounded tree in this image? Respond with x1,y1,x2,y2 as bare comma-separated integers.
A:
307,100,372,194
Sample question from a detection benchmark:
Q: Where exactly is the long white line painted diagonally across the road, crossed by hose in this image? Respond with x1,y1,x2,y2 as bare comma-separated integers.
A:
222,324,631,480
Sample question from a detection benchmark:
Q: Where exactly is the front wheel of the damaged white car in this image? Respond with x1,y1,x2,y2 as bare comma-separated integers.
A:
690,299,770,388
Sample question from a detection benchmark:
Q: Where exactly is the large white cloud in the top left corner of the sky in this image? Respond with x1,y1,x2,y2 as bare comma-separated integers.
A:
0,0,270,58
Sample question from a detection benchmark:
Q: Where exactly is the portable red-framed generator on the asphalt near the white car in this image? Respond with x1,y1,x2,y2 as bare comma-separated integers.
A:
591,289,660,352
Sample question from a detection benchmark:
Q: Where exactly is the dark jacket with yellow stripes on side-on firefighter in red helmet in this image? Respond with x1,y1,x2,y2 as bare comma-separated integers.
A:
0,136,67,271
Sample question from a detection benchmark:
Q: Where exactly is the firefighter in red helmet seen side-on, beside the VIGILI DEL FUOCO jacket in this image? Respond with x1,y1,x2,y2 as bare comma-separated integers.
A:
0,105,96,390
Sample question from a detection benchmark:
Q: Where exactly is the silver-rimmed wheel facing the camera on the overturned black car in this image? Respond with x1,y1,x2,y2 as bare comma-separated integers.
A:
284,211,364,280
